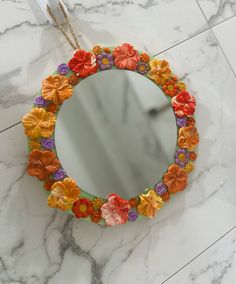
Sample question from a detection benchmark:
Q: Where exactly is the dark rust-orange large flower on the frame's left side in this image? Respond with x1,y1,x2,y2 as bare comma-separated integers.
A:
27,149,60,180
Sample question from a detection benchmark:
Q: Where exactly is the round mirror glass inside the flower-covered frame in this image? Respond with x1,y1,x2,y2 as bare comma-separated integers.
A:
55,70,177,199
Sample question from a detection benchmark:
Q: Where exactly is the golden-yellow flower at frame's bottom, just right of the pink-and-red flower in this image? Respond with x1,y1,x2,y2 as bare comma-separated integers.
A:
137,189,163,218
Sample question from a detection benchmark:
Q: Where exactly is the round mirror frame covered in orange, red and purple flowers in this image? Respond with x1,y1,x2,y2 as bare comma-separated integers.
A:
22,43,199,226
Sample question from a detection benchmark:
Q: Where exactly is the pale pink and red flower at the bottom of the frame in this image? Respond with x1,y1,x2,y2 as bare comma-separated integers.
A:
101,193,130,226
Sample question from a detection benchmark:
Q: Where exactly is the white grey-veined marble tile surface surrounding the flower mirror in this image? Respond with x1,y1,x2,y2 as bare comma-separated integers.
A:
0,0,236,284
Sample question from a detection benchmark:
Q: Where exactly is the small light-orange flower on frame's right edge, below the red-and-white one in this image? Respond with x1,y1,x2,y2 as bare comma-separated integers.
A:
178,126,199,151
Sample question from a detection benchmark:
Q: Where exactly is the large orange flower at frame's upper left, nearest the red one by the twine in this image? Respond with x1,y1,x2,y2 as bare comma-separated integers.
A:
42,75,73,104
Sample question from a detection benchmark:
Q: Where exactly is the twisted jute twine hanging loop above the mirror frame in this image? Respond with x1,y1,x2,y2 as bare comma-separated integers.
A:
47,1,80,50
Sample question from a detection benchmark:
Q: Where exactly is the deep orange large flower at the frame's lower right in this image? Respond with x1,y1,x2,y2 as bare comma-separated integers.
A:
163,164,187,193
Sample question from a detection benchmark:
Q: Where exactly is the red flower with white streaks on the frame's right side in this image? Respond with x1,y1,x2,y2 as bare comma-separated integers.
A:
172,91,196,117
